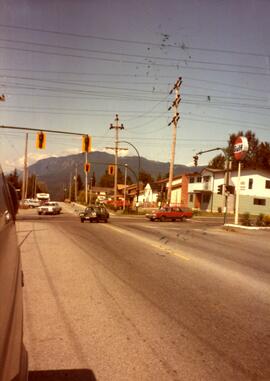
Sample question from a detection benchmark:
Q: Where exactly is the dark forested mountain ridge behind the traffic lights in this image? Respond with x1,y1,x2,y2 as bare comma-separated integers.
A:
29,151,192,199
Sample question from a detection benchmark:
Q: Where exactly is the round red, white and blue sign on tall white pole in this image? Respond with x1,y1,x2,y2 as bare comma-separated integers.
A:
233,136,248,225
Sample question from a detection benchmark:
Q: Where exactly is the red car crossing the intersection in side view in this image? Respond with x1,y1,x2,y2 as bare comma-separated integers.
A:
146,207,192,221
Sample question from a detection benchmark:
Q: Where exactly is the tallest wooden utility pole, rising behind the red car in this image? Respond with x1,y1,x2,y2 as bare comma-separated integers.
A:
167,77,182,204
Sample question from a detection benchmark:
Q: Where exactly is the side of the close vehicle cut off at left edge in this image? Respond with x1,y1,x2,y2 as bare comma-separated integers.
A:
0,167,28,381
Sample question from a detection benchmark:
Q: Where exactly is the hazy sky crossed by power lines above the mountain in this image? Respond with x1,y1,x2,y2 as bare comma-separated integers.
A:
0,0,270,171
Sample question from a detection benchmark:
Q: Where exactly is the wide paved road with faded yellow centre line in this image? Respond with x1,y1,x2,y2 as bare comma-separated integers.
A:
17,206,270,380
